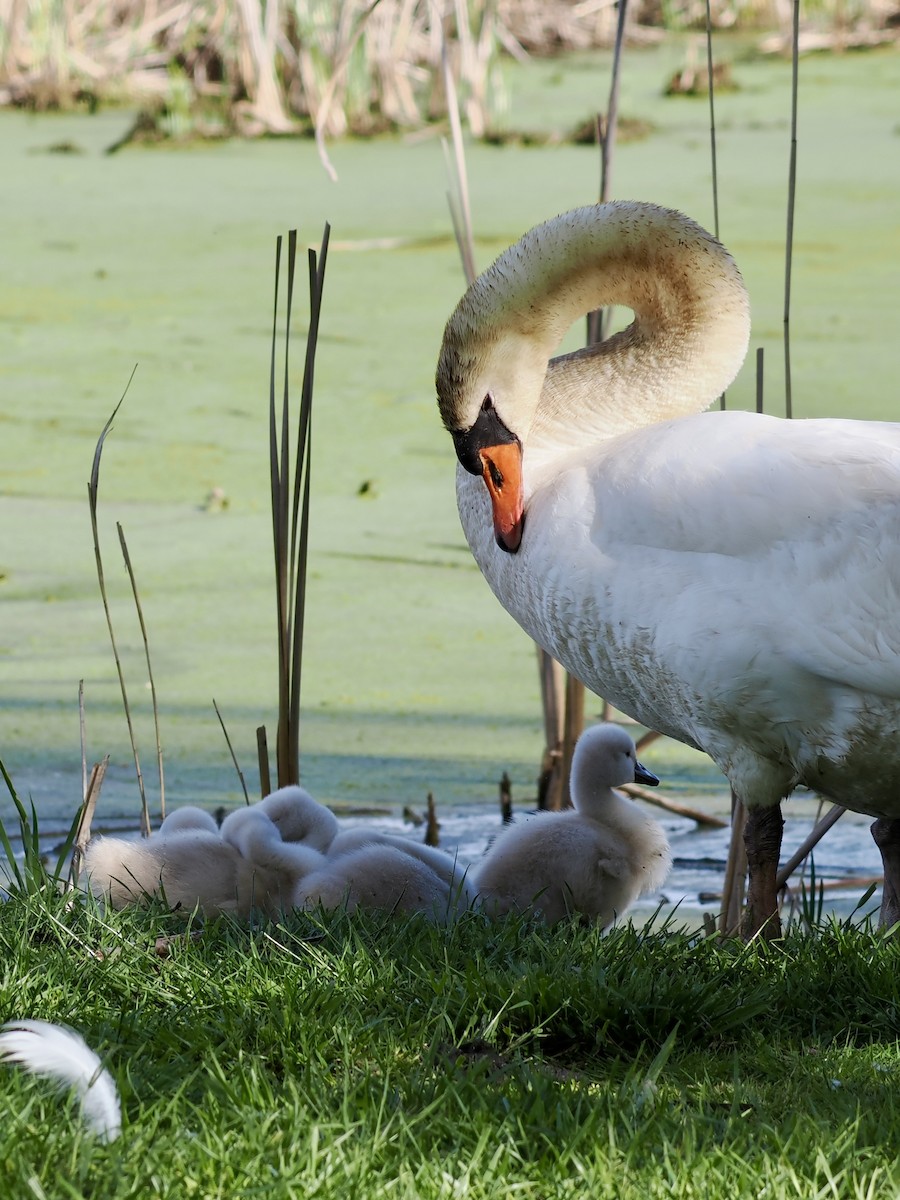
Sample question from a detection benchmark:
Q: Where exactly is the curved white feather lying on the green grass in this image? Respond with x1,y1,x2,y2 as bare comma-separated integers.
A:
0,1020,122,1141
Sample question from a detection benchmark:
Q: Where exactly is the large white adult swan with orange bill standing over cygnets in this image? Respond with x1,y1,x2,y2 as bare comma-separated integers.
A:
437,202,900,935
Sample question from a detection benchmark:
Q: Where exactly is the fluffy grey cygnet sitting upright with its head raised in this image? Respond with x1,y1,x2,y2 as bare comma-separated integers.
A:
473,725,672,929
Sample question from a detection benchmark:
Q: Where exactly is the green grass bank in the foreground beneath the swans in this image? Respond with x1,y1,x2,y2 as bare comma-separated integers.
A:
0,895,900,1200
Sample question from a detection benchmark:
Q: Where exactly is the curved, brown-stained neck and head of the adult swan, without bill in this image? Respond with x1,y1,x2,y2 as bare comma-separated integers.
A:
437,202,750,450
